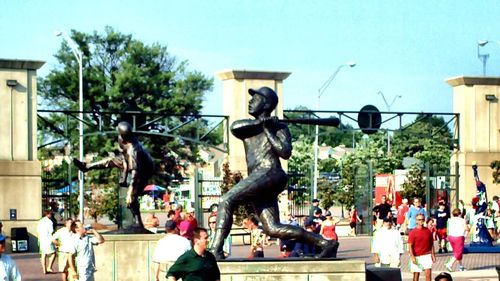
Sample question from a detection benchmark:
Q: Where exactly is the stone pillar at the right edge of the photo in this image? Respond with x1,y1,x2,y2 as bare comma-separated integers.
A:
447,76,500,203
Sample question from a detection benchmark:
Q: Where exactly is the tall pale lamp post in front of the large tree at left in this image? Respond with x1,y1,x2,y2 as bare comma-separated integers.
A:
54,31,84,223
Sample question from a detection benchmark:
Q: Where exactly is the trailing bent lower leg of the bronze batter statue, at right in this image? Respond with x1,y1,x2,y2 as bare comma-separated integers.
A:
255,201,339,258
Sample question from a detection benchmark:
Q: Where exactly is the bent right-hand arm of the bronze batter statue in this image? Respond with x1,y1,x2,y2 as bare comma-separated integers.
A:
263,116,292,159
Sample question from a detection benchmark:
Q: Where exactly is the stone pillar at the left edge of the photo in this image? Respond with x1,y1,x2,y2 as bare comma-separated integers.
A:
0,59,44,251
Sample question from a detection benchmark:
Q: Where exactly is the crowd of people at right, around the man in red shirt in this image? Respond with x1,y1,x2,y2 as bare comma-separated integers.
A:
371,192,500,280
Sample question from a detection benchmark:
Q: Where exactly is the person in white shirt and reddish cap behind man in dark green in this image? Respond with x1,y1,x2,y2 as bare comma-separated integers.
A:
153,220,191,280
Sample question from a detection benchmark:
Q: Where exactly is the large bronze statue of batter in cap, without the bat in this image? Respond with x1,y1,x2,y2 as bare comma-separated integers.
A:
211,87,338,259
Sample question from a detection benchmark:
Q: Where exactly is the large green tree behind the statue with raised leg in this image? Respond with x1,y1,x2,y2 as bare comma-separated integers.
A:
38,27,215,221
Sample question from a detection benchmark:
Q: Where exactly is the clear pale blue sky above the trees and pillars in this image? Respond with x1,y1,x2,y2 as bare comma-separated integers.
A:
0,0,500,122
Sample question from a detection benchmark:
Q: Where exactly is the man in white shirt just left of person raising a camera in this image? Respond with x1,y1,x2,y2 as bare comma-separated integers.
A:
52,218,75,281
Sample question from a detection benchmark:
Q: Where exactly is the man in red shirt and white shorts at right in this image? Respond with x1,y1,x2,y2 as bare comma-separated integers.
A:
408,214,436,281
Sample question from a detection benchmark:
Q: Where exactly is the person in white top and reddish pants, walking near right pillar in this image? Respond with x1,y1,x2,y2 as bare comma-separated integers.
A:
446,208,469,271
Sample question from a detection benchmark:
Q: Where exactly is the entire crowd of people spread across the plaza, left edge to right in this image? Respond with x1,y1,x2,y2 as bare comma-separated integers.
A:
0,190,500,280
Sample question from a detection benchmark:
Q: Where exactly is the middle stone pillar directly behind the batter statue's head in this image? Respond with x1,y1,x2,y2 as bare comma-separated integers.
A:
217,70,290,176
